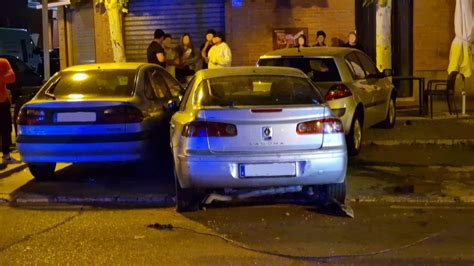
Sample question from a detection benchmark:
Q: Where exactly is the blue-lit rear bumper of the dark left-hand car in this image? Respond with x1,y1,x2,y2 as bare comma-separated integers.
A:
17,140,147,163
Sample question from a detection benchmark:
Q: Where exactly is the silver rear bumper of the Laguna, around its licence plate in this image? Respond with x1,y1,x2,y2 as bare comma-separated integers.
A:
175,147,347,188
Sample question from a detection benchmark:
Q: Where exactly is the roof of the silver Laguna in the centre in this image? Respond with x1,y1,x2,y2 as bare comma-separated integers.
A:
197,66,307,79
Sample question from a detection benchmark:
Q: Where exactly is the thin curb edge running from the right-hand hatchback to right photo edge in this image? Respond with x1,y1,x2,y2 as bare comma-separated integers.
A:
363,139,474,146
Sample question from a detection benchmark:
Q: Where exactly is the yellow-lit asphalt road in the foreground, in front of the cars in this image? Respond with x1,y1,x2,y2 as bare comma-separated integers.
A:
0,203,474,265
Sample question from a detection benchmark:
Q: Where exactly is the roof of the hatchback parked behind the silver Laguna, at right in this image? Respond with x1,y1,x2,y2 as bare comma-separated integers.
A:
260,47,356,58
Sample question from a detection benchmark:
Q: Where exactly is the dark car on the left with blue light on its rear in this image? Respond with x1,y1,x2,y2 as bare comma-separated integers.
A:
17,63,183,180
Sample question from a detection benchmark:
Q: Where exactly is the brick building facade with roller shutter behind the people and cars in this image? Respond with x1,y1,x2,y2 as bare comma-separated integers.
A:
58,0,474,96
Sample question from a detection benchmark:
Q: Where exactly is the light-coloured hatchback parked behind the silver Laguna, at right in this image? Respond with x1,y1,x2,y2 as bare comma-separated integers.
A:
257,47,397,155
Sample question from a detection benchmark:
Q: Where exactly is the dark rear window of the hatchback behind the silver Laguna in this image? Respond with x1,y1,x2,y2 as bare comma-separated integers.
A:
258,57,341,82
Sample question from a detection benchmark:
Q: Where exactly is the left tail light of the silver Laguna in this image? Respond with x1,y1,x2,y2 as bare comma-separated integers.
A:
182,121,237,138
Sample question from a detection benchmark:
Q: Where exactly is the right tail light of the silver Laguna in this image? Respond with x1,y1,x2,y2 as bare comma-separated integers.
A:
296,118,344,135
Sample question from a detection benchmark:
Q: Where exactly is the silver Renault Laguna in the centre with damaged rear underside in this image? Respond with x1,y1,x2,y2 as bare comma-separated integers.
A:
170,67,347,211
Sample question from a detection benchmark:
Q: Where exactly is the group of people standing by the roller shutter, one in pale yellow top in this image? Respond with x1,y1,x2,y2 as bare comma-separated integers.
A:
147,29,232,83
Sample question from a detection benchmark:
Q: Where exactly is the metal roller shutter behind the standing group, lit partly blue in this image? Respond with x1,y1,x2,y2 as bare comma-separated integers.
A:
124,0,225,62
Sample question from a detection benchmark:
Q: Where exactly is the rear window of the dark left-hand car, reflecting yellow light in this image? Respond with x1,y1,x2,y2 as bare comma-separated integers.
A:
39,69,135,99
